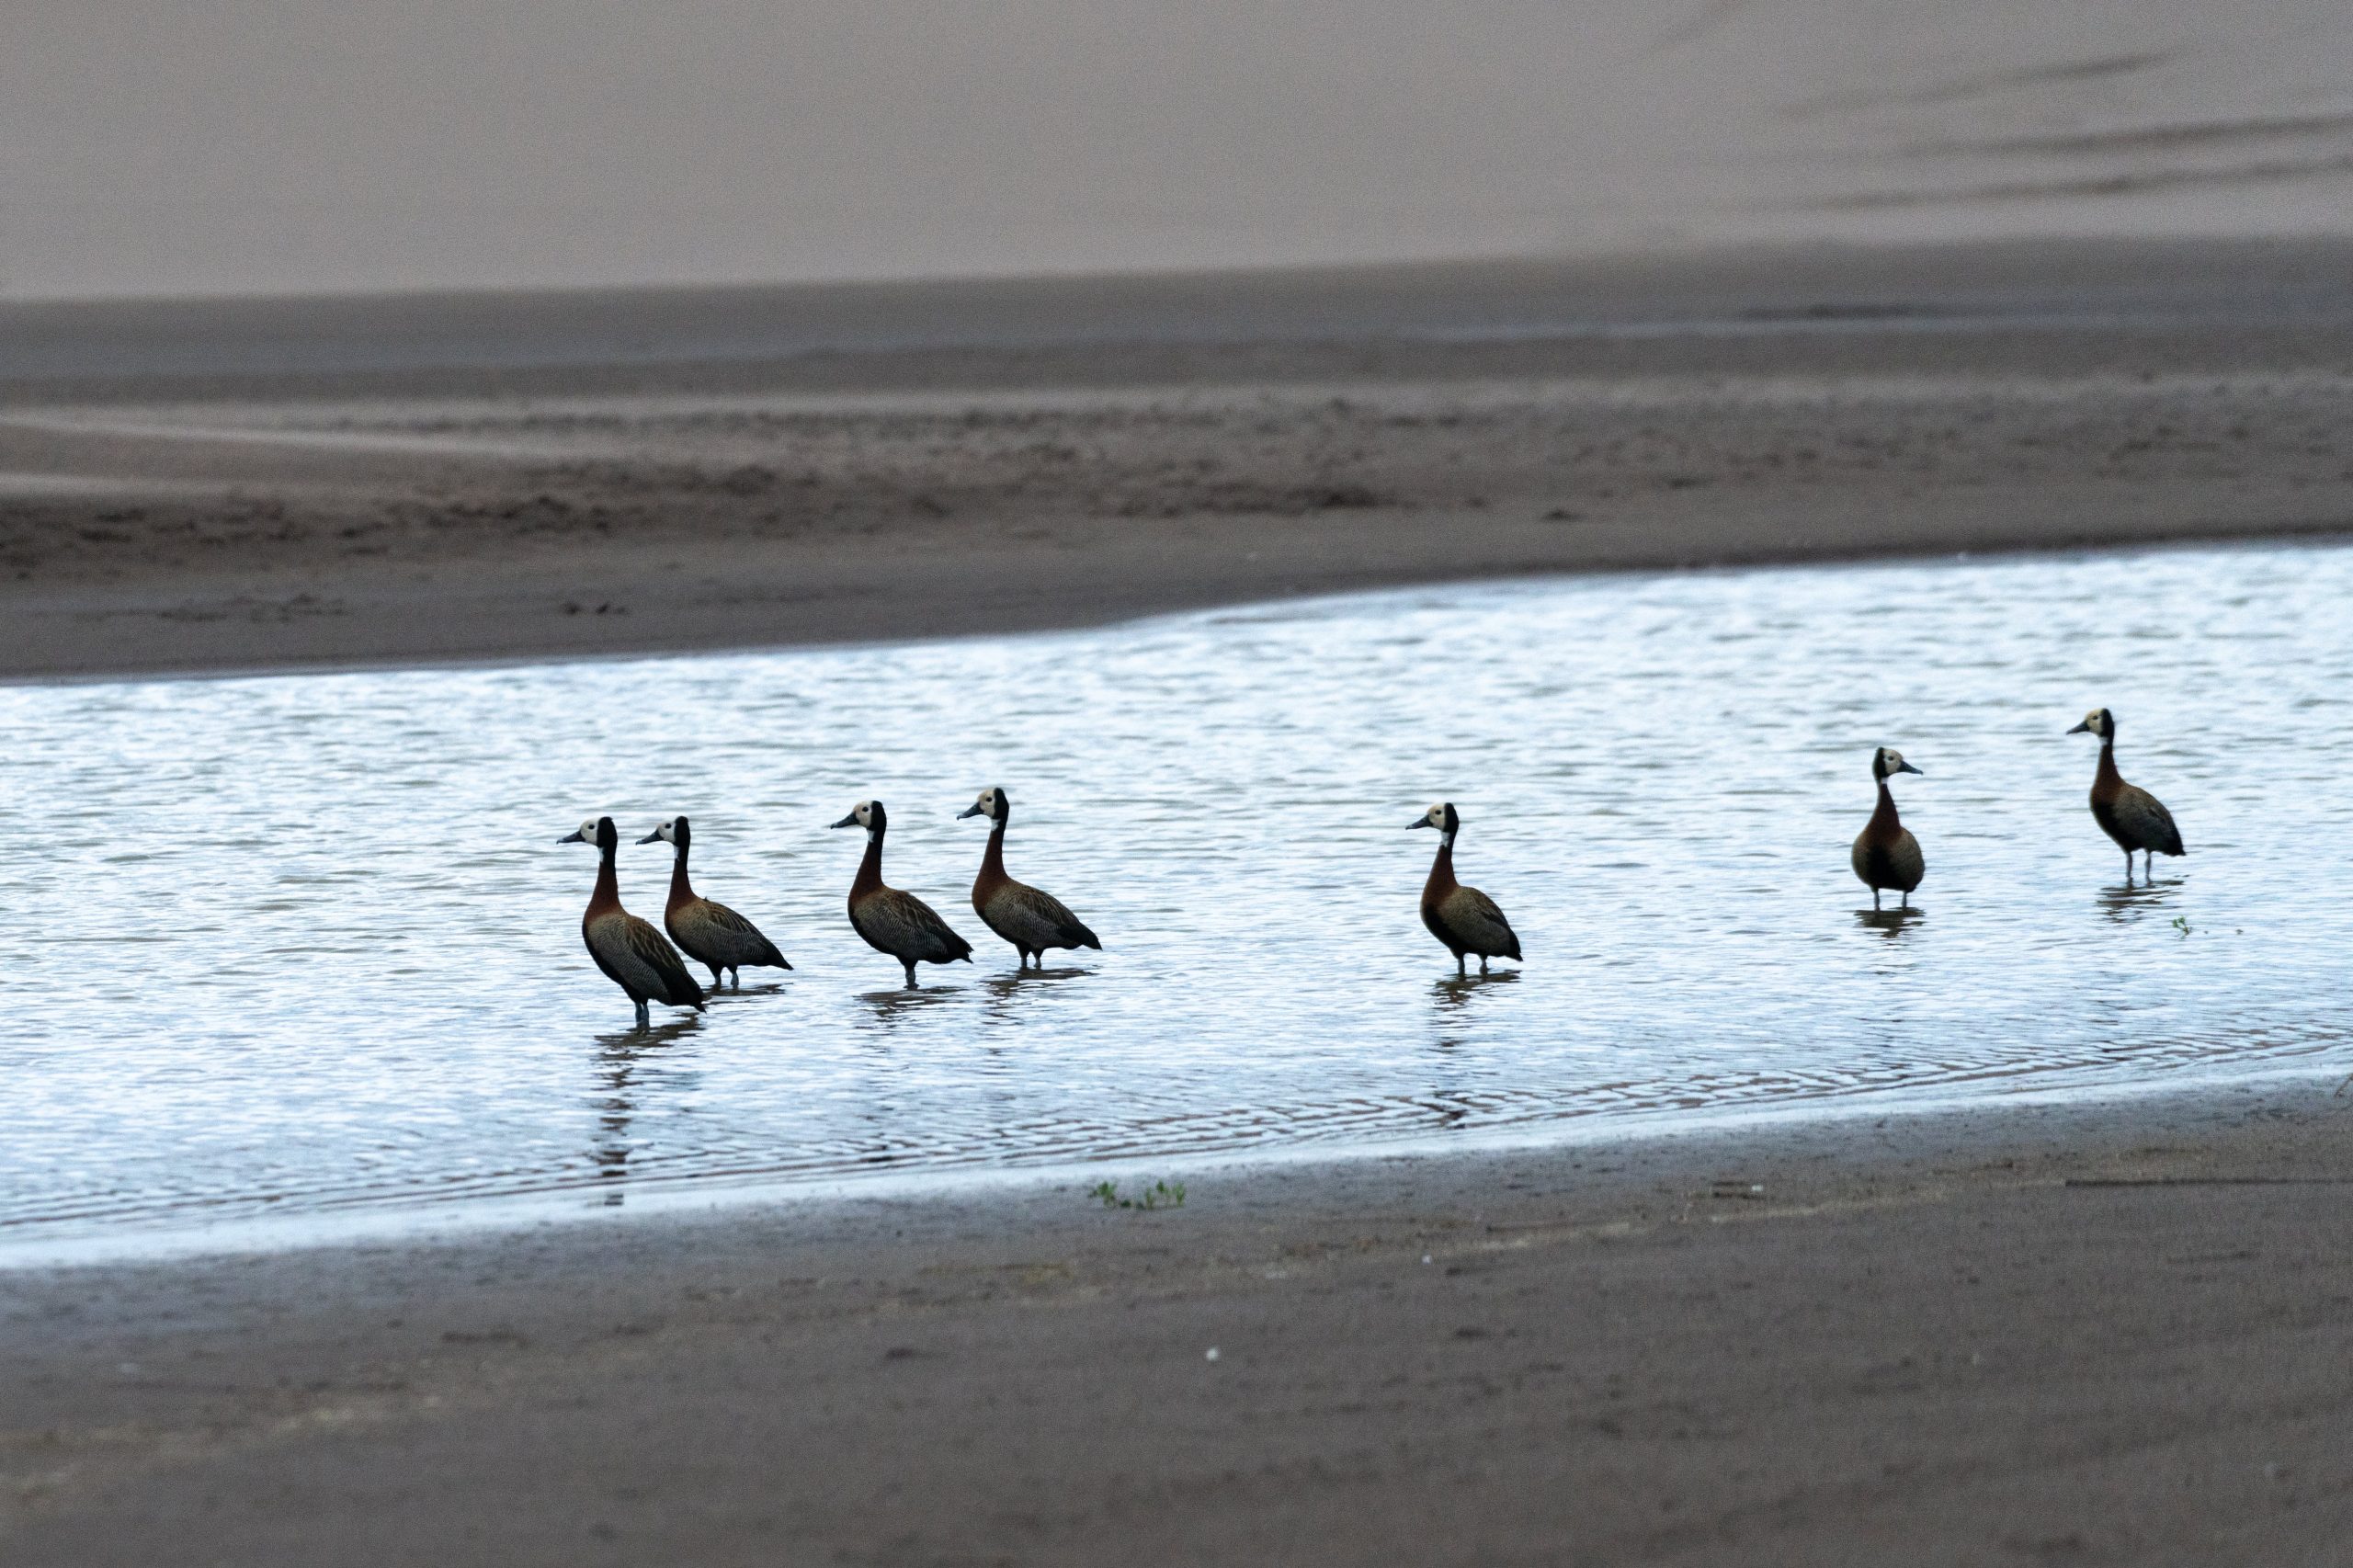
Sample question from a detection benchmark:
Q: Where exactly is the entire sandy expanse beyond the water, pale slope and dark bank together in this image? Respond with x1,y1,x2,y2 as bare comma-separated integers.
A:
14,0,2353,676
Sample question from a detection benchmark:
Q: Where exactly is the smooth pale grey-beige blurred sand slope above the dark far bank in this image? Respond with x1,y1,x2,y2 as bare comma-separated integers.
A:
14,0,2353,299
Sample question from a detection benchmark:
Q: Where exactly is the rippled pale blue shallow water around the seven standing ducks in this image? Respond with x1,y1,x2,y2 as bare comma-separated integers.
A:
0,549,2353,1248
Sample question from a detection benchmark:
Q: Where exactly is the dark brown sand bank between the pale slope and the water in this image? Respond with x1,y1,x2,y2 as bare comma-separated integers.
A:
14,243,2353,678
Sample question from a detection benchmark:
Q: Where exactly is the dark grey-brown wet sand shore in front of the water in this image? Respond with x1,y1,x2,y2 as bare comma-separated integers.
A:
0,1083,2353,1565
